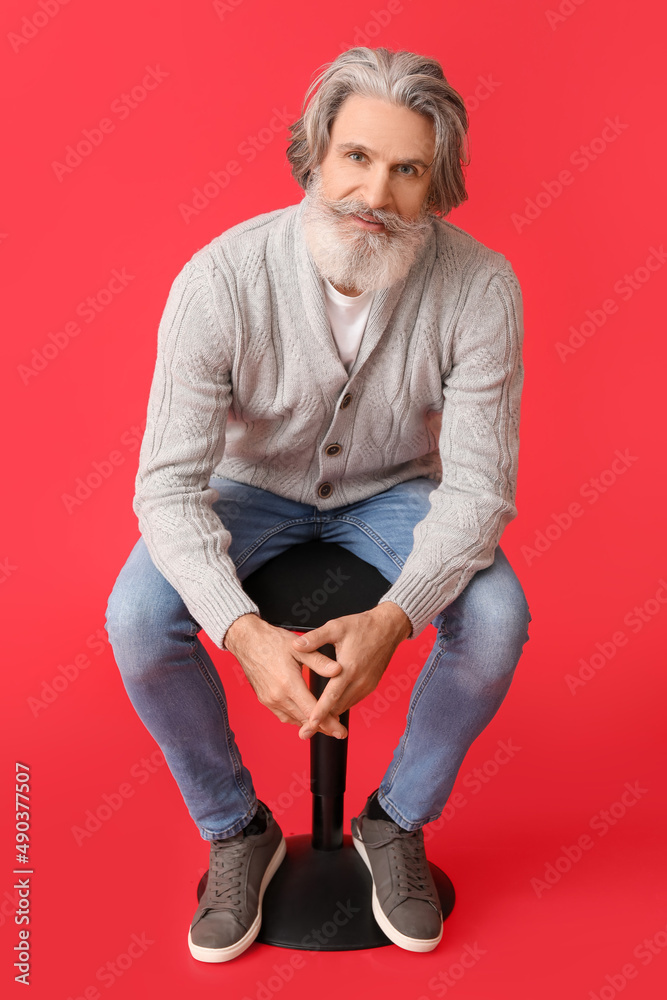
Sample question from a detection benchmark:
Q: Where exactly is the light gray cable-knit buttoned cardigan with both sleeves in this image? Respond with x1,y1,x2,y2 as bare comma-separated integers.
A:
133,200,523,649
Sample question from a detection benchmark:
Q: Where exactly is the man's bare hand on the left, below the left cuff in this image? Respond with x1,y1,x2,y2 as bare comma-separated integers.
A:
224,614,347,739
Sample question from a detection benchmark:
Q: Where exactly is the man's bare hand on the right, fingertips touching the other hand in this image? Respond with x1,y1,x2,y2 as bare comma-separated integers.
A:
292,601,412,739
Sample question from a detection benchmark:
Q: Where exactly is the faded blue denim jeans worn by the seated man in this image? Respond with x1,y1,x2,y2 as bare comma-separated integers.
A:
106,478,531,840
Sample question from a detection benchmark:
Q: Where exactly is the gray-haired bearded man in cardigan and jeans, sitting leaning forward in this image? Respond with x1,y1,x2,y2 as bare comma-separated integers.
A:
107,47,531,962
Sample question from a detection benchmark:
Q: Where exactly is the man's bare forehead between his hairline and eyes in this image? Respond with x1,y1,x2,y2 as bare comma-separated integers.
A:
331,94,435,162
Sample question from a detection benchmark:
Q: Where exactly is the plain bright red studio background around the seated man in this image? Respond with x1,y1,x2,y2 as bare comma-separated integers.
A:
0,0,667,1000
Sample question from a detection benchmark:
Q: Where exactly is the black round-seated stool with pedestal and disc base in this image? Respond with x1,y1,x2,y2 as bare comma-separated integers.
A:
198,541,455,951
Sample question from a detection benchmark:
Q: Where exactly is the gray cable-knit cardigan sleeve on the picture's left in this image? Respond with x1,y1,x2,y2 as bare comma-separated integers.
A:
133,260,259,649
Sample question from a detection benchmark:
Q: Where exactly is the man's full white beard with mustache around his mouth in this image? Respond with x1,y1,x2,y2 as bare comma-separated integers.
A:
303,167,431,292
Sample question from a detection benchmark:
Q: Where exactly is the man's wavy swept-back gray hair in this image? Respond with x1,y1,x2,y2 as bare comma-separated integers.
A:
287,46,469,216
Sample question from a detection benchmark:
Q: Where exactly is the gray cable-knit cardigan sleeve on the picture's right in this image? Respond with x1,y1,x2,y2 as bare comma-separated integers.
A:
380,261,524,638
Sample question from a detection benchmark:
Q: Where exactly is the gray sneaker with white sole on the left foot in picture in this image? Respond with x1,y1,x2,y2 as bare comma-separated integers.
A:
188,802,287,962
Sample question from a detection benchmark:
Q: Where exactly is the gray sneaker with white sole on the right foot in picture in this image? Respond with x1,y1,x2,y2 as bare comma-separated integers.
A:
352,792,442,951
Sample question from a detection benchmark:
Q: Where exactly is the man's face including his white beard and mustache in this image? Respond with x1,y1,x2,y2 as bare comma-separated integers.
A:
304,94,435,295
